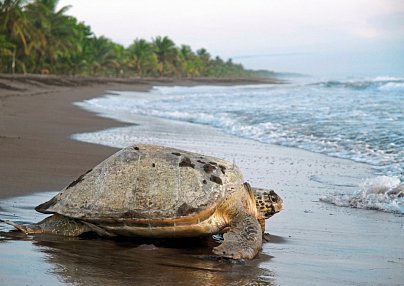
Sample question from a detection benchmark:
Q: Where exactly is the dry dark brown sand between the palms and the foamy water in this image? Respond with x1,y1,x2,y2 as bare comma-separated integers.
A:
0,74,279,198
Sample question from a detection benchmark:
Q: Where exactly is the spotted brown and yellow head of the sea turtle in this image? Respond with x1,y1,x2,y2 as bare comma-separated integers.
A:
252,188,283,219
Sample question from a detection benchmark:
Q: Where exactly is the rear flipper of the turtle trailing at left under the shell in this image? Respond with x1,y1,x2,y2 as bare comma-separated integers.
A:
2,214,93,236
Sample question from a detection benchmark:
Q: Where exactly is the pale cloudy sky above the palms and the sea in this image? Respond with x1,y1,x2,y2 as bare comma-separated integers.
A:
59,0,404,76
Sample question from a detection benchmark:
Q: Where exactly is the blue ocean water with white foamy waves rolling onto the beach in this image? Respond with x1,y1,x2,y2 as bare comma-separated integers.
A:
73,77,404,214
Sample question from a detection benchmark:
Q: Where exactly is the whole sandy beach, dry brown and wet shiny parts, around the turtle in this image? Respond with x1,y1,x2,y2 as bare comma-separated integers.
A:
0,76,404,285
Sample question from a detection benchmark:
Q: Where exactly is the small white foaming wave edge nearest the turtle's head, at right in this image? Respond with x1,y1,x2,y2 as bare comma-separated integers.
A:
320,176,404,214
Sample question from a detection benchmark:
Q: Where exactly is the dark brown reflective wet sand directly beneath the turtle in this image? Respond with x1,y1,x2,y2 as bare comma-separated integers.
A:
0,234,274,285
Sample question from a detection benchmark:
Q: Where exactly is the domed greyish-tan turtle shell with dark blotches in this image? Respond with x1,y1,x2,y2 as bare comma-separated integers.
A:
36,145,244,220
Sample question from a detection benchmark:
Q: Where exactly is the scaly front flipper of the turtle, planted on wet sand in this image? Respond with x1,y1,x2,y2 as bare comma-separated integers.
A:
213,213,262,259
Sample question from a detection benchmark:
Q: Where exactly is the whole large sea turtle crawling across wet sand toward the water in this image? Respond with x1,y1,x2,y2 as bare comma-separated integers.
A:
3,144,282,259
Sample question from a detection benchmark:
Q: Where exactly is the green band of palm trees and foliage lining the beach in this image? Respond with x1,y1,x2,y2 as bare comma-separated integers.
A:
0,0,254,77
